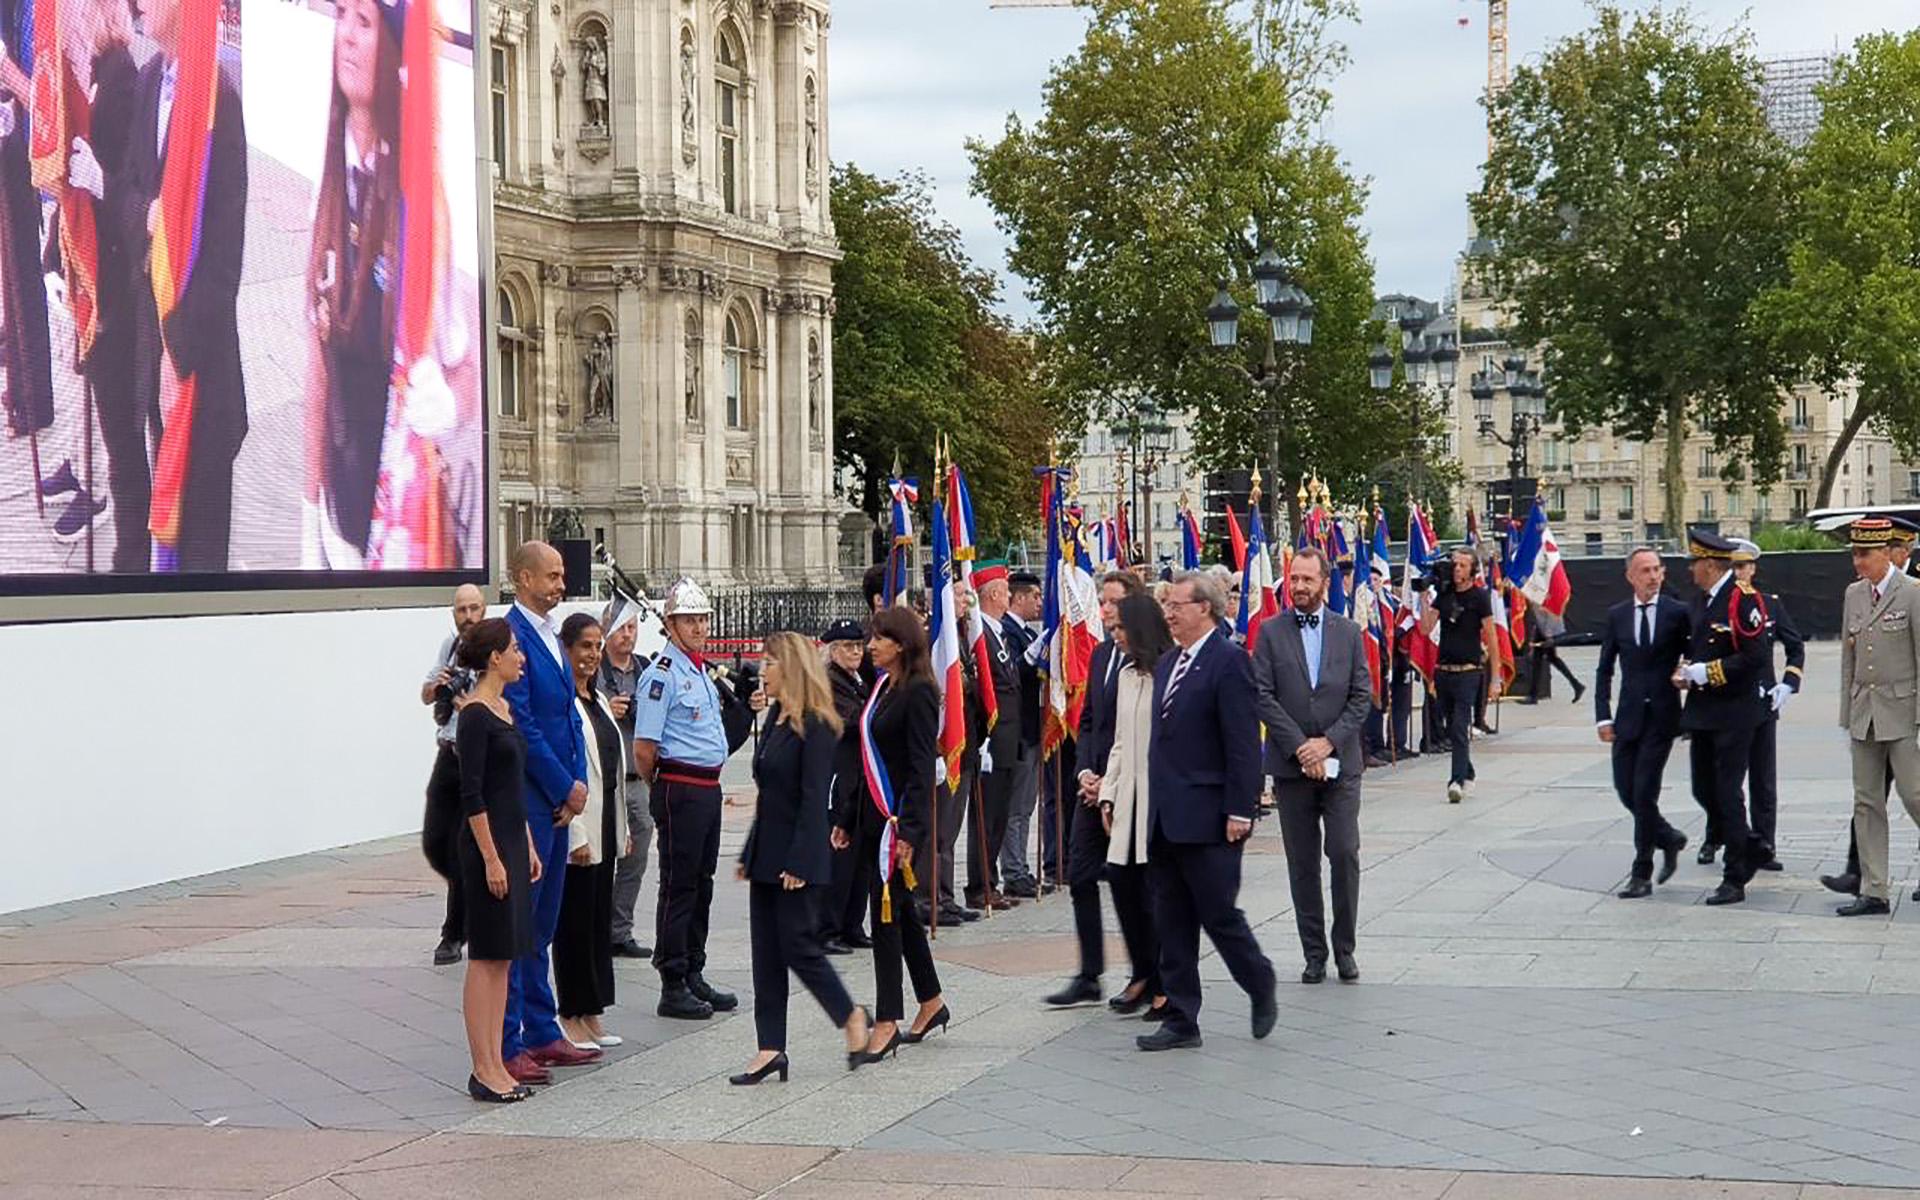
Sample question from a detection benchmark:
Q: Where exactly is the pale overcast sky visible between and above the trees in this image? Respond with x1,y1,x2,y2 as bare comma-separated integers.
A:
829,0,1920,317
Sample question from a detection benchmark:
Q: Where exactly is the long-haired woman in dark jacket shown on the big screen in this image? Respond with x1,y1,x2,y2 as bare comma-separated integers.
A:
301,0,401,570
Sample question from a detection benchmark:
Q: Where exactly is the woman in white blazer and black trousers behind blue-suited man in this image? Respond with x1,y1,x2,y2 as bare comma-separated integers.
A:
553,612,632,1050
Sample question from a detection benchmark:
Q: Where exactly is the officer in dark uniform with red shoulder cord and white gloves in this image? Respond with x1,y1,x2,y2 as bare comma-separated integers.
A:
1674,530,1774,904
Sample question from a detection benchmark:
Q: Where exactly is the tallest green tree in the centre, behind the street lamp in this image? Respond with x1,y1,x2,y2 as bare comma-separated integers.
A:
970,0,1405,533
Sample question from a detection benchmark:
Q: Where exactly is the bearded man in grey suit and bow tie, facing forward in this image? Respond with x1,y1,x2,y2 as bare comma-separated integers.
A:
1254,547,1373,983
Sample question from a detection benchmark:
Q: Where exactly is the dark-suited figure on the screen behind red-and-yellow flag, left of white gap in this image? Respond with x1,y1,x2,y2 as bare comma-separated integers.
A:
109,0,248,574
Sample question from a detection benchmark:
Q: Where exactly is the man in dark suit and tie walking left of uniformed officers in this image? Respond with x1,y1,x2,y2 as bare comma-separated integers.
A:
1594,545,1690,900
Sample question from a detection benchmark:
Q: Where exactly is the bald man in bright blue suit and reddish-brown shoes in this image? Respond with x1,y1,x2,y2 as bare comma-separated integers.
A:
501,541,599,1083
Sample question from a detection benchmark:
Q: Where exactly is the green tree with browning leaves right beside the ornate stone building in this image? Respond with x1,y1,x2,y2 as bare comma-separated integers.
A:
831,165,1054,538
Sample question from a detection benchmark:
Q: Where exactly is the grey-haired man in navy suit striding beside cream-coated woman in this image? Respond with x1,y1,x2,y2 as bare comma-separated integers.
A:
1137,572,1279,1050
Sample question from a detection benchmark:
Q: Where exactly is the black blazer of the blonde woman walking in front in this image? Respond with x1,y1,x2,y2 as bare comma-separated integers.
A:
739,705,839,883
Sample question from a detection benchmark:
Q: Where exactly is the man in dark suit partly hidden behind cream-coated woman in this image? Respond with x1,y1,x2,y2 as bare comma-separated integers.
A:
1046,570,1150,1008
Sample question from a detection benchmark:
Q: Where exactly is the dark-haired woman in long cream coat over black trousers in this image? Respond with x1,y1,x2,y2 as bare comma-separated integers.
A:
1100,593,1173,1021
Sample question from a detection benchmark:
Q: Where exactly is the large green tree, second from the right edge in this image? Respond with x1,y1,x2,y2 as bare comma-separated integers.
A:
1471,6,1793,532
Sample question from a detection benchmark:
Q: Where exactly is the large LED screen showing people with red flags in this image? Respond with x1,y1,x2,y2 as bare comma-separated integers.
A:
0,0,488,595
